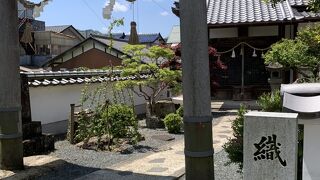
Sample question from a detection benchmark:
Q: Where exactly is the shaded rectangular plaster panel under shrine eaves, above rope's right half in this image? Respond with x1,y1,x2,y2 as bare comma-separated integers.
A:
248,26,279,37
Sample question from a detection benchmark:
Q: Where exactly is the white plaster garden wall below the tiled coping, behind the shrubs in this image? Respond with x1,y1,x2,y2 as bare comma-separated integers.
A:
29,83,166,124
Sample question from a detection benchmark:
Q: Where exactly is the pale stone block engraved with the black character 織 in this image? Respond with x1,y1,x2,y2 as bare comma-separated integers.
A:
243,112,298,180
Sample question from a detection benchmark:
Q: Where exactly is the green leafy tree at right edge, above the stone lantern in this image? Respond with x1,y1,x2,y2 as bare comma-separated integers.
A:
264,25,320,80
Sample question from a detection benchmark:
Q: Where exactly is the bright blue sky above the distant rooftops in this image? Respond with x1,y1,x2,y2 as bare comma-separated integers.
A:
33,0,179,37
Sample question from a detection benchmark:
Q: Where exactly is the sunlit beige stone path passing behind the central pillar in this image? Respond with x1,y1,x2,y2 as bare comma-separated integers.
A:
79,115,236,180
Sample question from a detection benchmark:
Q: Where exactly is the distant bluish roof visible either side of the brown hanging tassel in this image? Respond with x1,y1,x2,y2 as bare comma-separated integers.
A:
112,33,163,44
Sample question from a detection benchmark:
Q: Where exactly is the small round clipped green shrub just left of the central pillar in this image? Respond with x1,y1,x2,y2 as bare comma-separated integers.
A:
164,113,182,134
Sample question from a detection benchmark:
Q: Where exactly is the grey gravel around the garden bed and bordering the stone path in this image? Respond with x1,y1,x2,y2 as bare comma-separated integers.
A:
34,113,242,180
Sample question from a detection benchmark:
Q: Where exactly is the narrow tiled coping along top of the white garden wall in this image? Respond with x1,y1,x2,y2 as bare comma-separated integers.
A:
20,70,148,87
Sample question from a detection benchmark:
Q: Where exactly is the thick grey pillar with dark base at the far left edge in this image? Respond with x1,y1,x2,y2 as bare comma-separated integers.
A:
0,0,23,170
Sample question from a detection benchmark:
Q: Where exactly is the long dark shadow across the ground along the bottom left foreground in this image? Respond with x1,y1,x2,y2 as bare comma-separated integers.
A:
4,160,176,180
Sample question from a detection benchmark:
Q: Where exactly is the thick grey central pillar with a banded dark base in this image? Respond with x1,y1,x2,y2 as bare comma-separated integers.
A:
180,0,214,180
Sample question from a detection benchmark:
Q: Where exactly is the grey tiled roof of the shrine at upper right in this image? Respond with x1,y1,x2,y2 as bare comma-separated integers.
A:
207,0,320,25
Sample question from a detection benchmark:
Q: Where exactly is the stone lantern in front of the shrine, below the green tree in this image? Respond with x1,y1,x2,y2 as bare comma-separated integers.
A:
266,63,284,92
